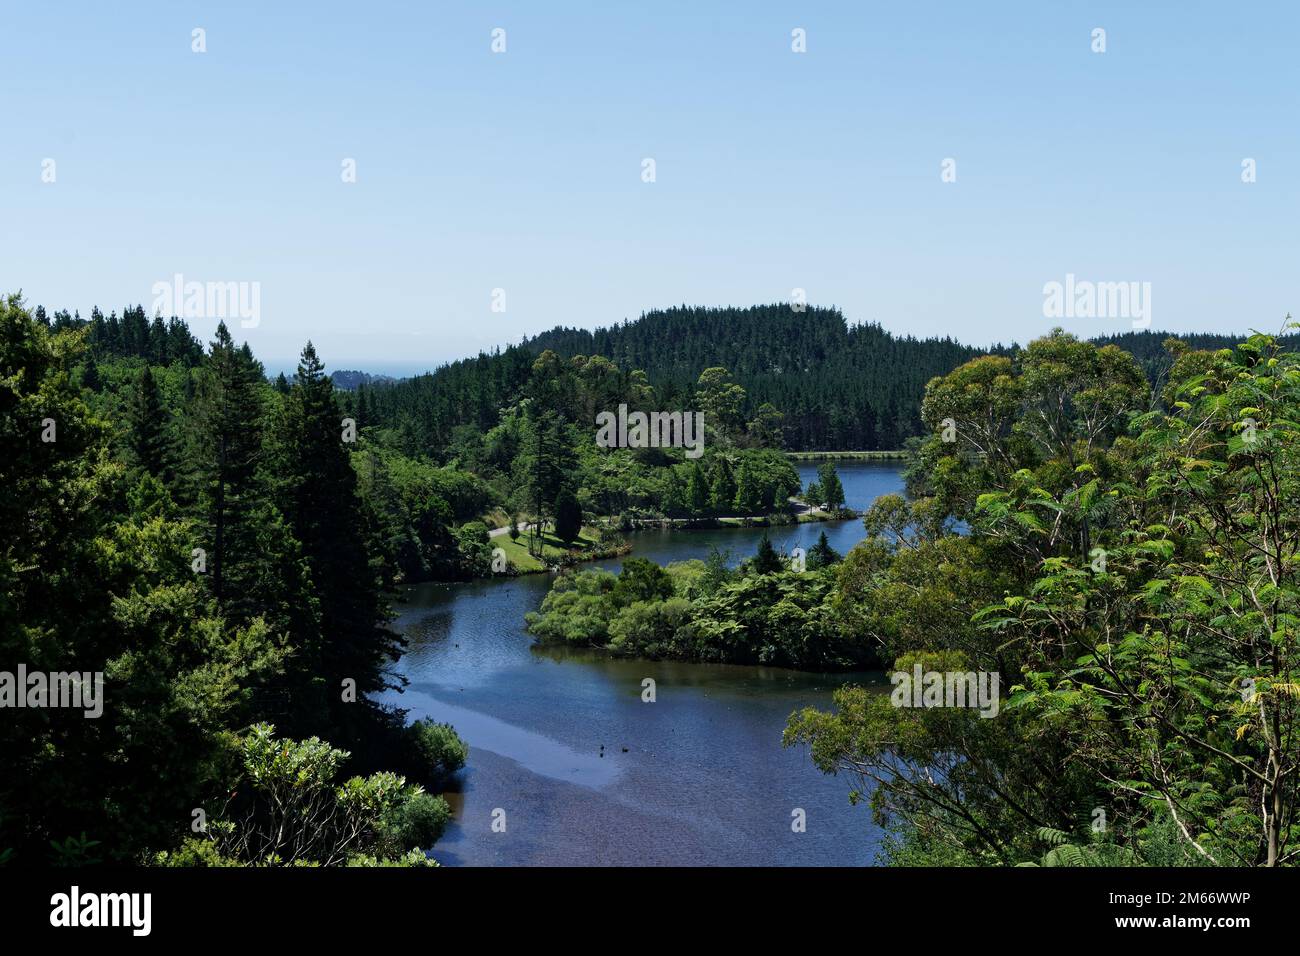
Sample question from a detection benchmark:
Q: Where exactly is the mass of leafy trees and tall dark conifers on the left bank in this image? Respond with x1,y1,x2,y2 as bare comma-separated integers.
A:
0,297,452,865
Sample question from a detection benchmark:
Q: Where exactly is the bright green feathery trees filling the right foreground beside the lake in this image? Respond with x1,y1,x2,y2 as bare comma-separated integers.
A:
787,325,1300,865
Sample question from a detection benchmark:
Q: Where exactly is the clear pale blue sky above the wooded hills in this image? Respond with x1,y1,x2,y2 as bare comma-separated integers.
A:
0,0,1300,373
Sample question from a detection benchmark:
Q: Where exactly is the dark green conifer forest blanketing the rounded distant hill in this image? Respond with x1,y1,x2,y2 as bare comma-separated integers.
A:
368,303,1008,455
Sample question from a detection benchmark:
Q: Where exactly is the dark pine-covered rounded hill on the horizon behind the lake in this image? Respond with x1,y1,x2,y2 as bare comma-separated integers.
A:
353,303,1279,450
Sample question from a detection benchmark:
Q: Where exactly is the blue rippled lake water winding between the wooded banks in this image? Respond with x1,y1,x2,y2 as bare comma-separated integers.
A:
385,462,902,866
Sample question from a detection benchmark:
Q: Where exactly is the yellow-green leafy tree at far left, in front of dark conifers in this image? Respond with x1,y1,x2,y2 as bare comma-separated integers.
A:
0,297,280,866
